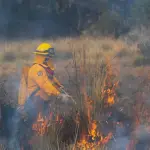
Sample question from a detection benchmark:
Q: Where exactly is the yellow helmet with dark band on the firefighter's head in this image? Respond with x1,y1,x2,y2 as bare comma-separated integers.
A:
34,43,55,57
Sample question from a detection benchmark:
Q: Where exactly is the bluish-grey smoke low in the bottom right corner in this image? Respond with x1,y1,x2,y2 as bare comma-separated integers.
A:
106,107,150,150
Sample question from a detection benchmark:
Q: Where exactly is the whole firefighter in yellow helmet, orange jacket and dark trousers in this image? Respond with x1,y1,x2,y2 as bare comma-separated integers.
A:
10,43,71,150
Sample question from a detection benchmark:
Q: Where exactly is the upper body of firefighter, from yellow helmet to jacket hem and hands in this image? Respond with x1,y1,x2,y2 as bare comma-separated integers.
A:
18,43,68,106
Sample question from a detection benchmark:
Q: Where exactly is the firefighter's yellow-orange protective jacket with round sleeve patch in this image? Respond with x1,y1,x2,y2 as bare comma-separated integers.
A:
28,64,60,100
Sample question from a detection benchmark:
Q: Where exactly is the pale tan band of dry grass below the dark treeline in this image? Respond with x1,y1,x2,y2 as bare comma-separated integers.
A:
0,36,137,74
